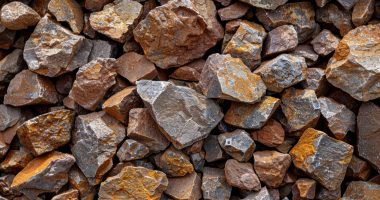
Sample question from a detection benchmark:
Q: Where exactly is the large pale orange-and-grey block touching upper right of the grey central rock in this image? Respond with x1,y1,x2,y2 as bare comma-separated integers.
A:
199,54,266,103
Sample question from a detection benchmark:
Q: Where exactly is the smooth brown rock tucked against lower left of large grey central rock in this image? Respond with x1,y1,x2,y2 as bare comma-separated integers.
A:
127,108,170,153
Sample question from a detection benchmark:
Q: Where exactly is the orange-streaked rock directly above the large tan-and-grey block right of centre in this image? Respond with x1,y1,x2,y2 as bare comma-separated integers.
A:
223,21,267,69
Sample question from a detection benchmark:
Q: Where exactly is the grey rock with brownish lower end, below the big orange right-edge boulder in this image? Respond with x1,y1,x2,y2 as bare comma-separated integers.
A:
318,97,356,140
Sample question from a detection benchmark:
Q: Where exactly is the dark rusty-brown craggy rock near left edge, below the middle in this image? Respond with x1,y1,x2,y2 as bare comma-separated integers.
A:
17,109,75,156
